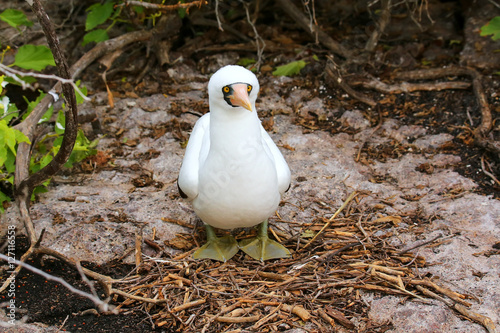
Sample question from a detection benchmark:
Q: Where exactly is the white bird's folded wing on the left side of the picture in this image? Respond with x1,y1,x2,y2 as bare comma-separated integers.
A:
177,113,210,200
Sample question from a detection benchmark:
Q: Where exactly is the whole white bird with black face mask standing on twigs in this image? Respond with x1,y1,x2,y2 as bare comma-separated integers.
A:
177,66,290,261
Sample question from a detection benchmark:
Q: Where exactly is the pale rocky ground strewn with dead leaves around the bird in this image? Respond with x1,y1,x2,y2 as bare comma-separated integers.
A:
1,1,500,332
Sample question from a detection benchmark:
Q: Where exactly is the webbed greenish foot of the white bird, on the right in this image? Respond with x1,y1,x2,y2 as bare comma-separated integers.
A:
239,220,291,261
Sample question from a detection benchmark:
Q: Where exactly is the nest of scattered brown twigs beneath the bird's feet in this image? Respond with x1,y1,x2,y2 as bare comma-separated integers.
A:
115,193,492,332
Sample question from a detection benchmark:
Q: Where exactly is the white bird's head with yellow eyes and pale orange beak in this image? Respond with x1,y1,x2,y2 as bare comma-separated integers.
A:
208,65,260,112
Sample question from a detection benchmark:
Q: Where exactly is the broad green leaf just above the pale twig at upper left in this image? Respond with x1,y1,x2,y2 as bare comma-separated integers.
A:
13,44,56,71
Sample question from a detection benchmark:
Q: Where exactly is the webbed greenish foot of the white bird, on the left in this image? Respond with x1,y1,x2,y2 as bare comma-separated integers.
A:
193,224,238,262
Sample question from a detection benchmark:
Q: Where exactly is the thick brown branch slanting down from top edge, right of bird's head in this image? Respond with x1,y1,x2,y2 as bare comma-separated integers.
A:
278,0,351,58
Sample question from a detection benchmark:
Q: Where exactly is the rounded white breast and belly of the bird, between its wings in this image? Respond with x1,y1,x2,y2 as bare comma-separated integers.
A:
193,117,280,229
